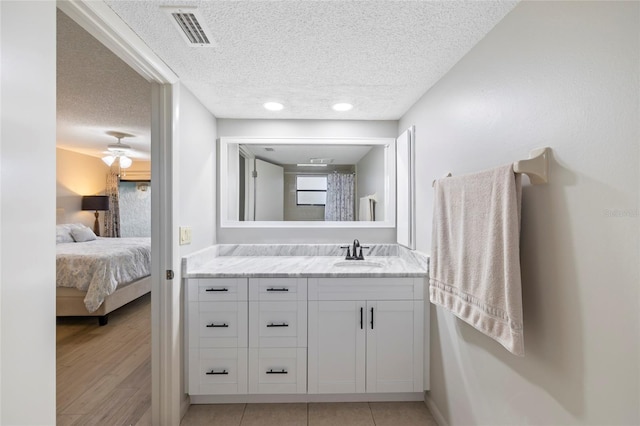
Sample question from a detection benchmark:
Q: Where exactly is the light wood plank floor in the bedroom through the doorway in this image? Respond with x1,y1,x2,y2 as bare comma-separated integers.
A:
56,294,151,426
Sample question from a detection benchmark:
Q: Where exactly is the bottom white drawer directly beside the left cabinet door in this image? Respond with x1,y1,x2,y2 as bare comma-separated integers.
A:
249,348,307,393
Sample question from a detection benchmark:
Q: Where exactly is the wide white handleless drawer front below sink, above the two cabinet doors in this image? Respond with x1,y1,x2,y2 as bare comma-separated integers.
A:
309,277,426,300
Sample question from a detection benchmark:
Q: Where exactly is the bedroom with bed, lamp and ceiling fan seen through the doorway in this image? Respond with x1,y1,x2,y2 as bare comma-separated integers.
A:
56,11,152,424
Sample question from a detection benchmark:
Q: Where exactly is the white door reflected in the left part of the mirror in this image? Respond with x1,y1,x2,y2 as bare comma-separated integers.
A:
255,159,284,220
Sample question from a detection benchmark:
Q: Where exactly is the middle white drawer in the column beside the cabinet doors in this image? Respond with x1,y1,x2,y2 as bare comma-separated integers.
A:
249,301,307,348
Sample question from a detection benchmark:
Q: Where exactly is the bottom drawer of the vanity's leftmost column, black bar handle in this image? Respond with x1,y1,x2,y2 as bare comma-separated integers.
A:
189,348,247,395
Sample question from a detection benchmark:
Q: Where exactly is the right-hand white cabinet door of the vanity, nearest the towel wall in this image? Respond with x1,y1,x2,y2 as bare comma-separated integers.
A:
367,300,423,392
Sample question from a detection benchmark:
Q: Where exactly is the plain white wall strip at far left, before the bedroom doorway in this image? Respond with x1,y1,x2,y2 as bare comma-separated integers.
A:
0,1,56,425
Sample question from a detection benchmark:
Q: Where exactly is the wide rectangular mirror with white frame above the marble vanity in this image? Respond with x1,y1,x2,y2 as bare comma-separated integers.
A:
218,138,396,227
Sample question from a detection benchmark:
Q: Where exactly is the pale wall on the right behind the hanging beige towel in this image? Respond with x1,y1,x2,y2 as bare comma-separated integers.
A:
399,2,640,425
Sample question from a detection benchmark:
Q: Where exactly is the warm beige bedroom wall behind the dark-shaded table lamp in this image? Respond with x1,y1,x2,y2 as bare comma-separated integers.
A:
56,148,109,230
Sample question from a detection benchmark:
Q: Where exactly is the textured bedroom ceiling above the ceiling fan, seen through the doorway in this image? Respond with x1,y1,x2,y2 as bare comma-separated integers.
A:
56,10,151,159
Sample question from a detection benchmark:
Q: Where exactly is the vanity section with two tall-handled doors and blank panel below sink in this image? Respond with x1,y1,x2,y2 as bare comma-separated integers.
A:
308,278,425,394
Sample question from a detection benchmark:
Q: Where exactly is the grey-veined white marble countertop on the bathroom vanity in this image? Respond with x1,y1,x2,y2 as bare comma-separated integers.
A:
183,246,428,278
